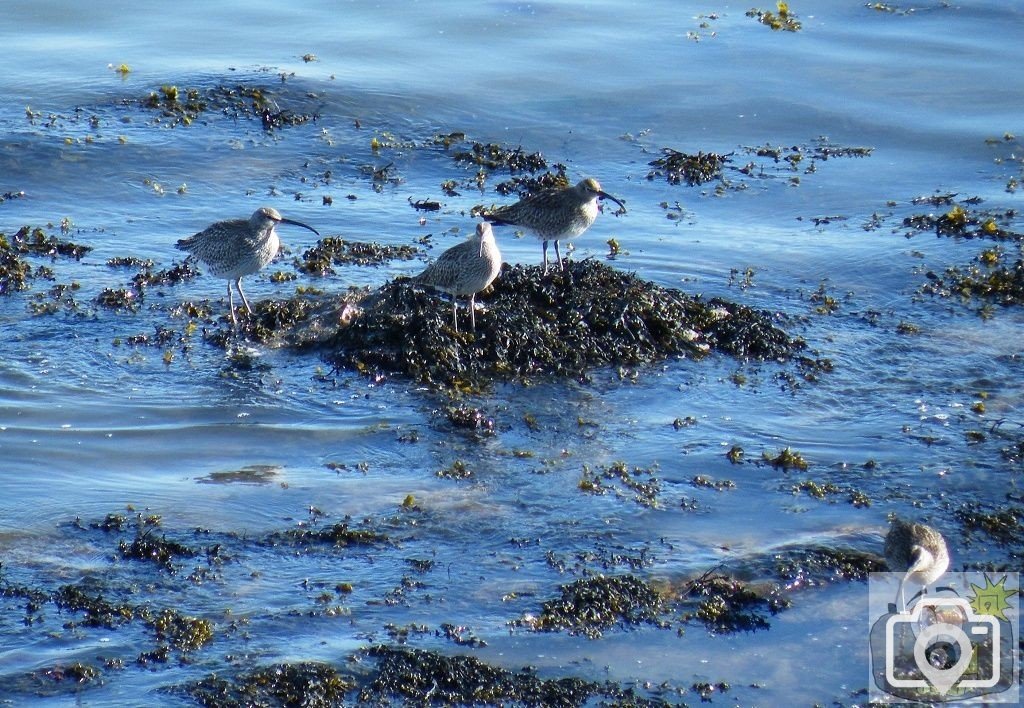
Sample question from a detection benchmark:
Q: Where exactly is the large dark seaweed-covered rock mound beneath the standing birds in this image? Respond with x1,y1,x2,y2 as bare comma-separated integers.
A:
327,260,804,388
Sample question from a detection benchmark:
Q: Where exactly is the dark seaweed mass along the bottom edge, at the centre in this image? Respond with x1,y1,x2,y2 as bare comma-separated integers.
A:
358,645,622,706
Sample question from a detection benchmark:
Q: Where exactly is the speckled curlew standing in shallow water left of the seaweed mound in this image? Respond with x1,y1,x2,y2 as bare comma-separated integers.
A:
176,207,319,328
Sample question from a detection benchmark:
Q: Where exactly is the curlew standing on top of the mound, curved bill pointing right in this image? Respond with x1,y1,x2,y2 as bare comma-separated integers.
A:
482,177,626,274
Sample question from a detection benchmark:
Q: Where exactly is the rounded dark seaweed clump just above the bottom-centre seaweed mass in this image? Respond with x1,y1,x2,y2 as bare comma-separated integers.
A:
510,575,664,639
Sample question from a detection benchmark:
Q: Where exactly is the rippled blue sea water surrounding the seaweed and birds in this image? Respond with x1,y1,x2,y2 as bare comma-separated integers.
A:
0,0,1024,705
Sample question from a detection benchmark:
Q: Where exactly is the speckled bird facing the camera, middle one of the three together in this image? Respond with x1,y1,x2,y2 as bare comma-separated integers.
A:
413,221,502,332
